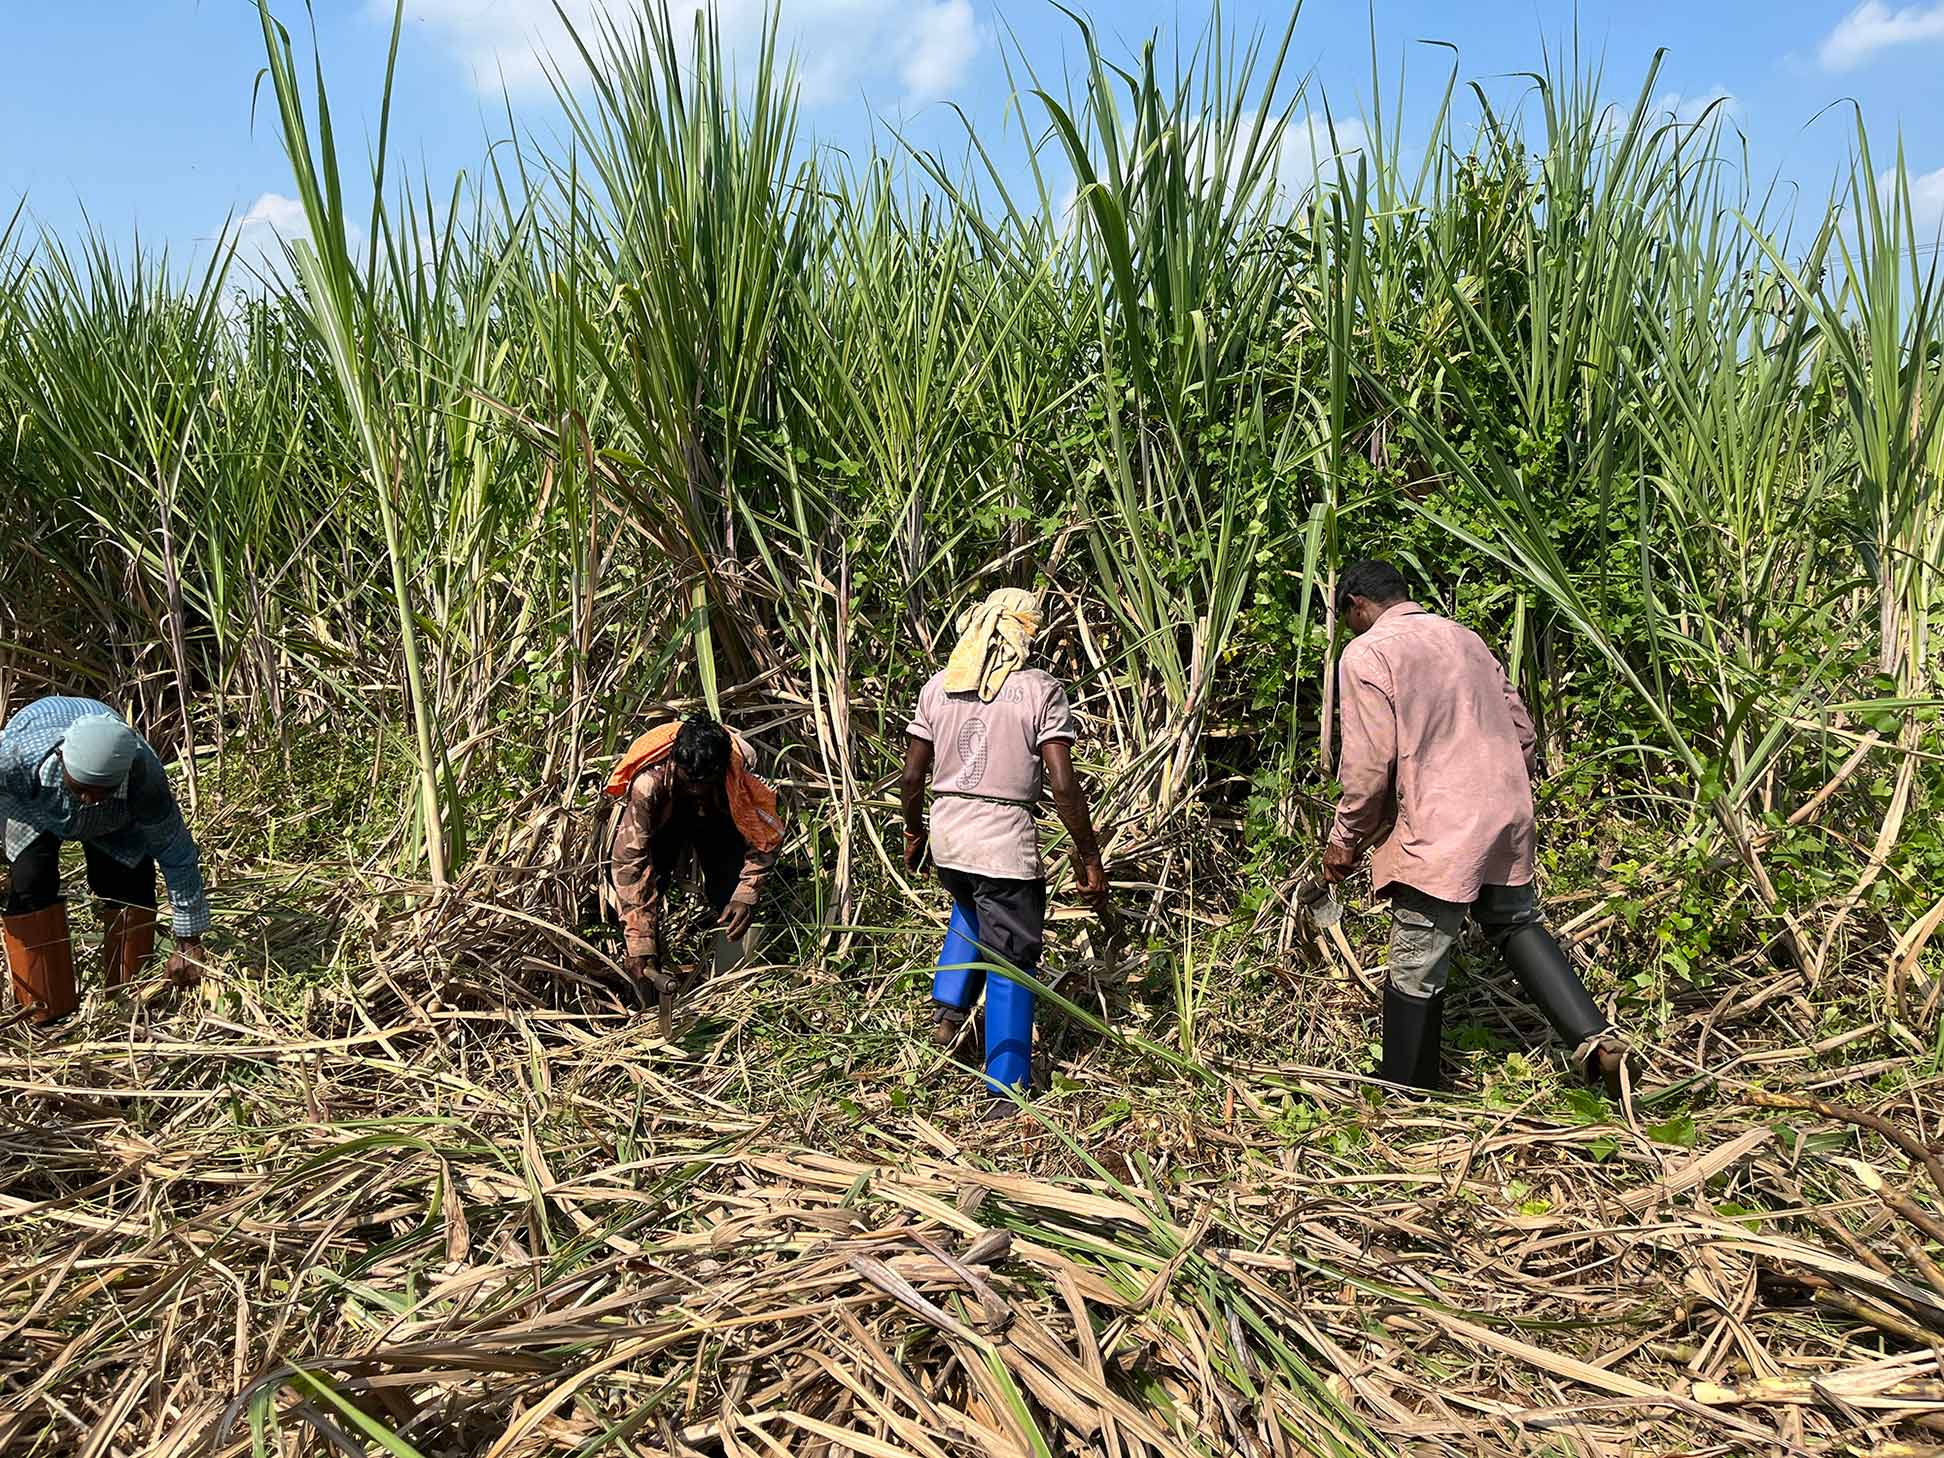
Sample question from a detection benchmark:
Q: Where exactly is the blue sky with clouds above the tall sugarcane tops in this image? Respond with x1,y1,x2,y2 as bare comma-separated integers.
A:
0,0,1944,255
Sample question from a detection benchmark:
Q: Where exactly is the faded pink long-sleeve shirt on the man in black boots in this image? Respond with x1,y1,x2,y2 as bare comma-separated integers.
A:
1330,603,1534,902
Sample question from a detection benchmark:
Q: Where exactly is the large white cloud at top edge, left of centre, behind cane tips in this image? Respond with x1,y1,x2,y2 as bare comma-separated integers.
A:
382,0,986,103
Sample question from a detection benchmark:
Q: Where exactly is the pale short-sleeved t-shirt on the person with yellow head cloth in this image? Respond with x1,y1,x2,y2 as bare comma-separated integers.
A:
904,669,1079,881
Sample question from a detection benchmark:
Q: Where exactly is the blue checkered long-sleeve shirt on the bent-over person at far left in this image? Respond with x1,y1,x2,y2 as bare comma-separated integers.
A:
0,698,210,937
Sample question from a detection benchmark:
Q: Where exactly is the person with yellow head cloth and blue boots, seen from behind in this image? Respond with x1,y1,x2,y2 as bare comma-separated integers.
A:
900,589,1106,1116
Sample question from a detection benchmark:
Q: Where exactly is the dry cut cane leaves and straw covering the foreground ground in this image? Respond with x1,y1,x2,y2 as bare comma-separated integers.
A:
11,816,1944,1456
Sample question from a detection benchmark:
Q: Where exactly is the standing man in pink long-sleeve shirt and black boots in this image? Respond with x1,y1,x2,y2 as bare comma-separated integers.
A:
1322,562,1625,1091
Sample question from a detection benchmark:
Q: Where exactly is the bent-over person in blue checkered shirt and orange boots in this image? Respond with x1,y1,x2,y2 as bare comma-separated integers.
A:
0,698,210,1023
